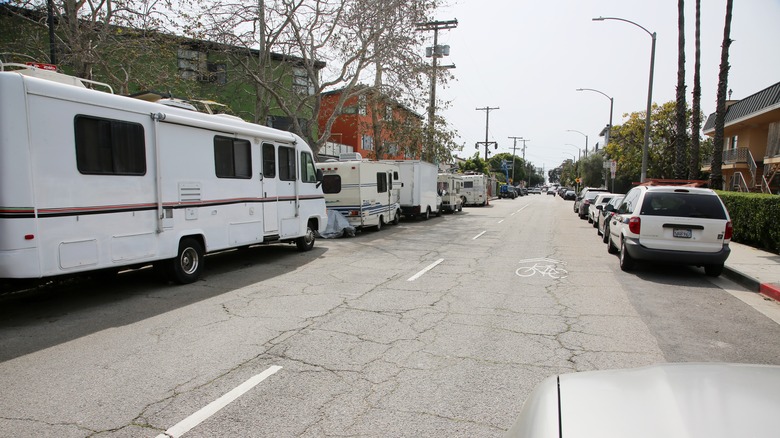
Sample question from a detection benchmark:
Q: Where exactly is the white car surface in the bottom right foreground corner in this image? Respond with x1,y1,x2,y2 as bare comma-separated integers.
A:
505,363,780,438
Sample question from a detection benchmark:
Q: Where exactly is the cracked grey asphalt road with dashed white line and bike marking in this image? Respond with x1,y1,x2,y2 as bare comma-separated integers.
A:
0,195,780,437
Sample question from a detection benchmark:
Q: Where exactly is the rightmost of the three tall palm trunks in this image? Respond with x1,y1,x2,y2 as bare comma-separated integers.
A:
710,0,734,190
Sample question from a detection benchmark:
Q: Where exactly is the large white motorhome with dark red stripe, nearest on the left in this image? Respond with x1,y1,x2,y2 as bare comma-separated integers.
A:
0,64,327,283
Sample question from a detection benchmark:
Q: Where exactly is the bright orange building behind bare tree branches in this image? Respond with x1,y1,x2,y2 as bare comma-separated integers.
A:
317,89,423,160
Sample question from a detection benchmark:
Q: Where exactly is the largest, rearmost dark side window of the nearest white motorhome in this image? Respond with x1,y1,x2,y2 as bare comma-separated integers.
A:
74,116,146,175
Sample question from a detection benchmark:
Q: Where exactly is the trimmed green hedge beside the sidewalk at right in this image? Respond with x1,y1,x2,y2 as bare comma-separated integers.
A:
718,191,780,254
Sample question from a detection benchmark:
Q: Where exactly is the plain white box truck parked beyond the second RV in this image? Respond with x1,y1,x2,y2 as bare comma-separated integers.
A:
382,160,441,219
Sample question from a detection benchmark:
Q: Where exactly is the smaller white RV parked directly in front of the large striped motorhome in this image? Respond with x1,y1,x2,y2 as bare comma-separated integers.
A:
316,153,401,231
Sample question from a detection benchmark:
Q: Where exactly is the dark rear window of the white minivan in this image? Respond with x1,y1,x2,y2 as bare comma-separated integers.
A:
640,192,726,219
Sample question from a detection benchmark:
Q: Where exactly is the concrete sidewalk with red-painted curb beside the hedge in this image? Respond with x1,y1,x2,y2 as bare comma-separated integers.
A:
723,242,780,301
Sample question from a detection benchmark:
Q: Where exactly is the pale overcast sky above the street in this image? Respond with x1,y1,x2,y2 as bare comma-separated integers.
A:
434,0,780,178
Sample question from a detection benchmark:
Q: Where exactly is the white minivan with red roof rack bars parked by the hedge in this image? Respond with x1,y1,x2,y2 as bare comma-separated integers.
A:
607,186,733,277
